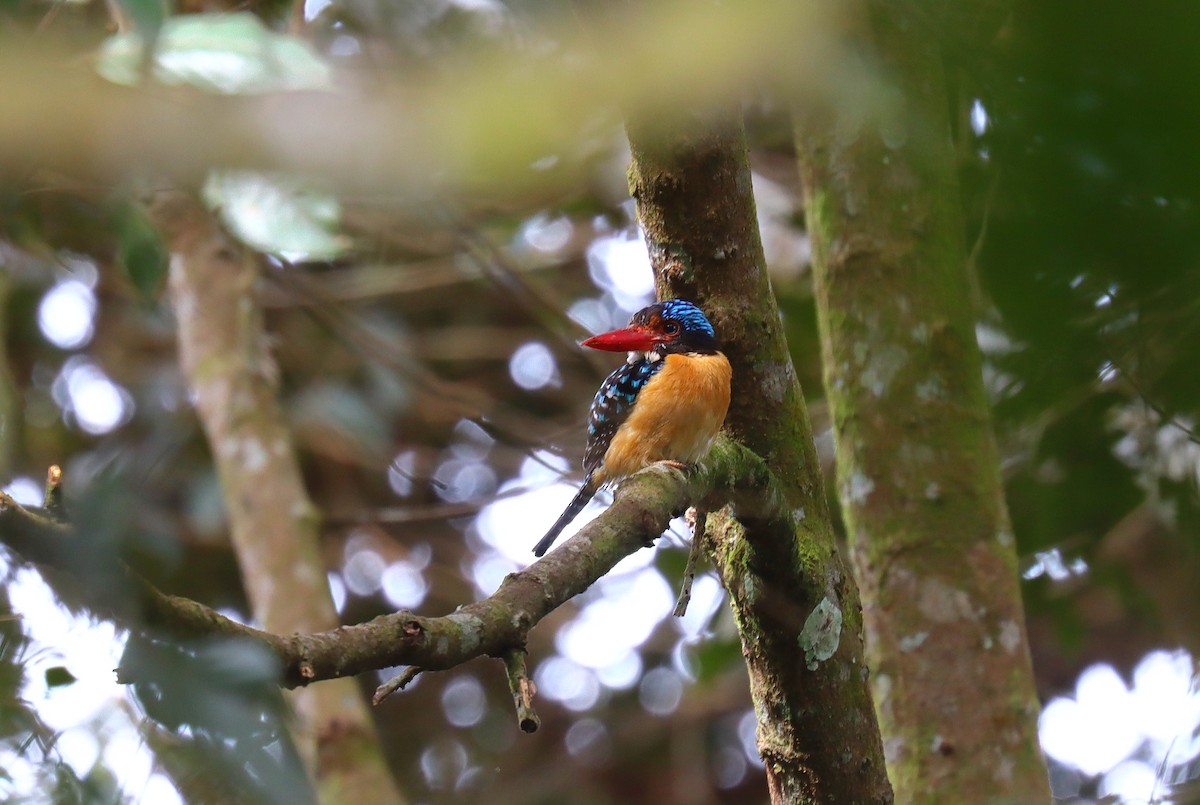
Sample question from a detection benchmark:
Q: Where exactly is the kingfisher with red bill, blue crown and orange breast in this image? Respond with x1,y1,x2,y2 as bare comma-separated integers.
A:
533,299,733,557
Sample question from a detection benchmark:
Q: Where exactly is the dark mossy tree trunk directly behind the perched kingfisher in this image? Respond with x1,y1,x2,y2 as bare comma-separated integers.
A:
629,110,892,804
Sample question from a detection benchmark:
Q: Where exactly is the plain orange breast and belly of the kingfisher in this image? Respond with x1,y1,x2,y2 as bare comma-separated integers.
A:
602,353,733,481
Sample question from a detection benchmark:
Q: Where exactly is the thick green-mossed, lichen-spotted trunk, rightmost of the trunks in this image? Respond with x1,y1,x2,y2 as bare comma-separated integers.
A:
797,4,1050,804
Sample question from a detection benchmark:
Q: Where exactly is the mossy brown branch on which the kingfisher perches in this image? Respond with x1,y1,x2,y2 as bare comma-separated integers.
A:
0,438,787,695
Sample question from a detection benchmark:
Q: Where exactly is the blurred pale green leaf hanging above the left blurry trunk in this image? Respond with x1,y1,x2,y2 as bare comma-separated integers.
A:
204,170,350,260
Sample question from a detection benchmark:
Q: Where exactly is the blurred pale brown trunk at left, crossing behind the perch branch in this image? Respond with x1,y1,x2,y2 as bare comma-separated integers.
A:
151,192,403,803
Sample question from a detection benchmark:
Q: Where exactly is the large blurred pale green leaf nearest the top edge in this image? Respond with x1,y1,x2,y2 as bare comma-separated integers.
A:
96,12,332,95
